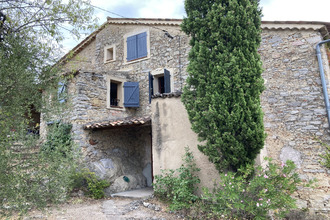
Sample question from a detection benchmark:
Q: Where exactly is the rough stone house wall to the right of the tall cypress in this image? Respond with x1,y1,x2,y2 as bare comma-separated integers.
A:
259,30,330,212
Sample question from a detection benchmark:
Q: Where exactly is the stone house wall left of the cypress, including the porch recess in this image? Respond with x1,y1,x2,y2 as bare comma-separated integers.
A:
49,25,189,193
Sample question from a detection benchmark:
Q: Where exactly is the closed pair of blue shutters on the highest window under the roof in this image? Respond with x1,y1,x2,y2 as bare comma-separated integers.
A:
126,32,148,61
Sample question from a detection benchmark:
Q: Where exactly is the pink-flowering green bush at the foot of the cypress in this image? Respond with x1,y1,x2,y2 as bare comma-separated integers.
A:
196,159,311,219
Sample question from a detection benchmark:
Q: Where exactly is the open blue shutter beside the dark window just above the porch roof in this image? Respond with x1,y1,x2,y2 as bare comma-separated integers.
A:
124,82,140,107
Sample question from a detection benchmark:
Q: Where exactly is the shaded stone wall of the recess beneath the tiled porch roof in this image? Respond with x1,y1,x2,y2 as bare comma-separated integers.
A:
73,125,152,194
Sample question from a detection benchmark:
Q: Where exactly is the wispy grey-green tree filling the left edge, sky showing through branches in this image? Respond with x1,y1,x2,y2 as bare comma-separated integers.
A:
0,0,96,216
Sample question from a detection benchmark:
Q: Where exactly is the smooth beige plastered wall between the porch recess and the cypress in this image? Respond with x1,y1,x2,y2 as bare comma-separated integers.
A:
151,97,219,193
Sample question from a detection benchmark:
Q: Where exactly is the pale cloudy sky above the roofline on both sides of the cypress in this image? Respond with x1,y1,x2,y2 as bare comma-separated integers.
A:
63,0,330,51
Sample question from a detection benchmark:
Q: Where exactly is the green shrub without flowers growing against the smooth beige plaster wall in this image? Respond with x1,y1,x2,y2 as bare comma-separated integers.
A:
154,148,200,210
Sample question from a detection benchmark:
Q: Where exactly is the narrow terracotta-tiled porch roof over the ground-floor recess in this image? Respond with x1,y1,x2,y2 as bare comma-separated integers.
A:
83,116,151,130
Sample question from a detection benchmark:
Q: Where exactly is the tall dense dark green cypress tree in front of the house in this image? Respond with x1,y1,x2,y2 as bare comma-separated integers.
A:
181,0,265,171
